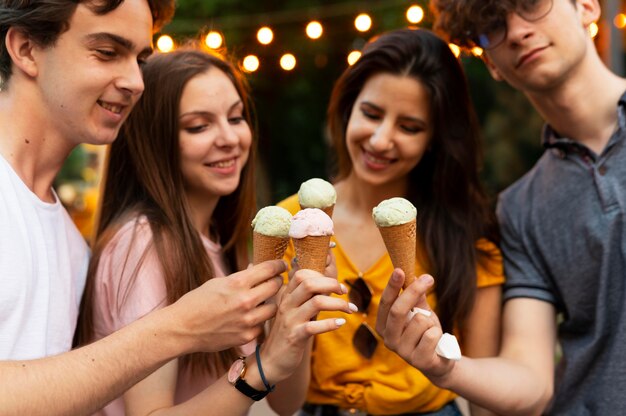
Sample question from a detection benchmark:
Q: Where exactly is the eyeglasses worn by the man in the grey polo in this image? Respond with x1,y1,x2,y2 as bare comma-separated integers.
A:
468,0,554,50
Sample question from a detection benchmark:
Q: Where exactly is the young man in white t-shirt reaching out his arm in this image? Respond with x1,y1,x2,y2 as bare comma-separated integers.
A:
0,0,285,415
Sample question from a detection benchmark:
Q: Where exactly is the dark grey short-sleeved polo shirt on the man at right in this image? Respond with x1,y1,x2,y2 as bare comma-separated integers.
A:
498,94,626,416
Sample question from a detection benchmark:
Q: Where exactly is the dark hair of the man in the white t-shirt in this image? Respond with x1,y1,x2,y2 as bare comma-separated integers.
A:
0,0,175,86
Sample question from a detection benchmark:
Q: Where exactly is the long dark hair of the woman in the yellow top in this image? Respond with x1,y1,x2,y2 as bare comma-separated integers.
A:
327,29,499,332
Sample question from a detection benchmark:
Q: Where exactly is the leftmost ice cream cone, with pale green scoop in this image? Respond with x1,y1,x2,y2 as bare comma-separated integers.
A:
252,206,291,264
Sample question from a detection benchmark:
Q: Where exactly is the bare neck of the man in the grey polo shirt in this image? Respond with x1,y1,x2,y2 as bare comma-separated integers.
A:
526,47,626,154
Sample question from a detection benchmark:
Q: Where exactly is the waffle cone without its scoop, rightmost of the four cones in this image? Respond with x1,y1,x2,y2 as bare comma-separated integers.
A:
378,219,416,288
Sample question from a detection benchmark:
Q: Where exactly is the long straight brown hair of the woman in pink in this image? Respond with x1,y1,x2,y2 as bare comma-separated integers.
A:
77,46,255,372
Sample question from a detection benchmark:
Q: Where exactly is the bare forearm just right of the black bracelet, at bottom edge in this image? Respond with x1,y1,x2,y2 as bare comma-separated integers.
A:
267,338,313,416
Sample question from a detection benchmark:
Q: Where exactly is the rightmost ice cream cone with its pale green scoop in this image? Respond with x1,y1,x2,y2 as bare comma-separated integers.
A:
372,198,417,288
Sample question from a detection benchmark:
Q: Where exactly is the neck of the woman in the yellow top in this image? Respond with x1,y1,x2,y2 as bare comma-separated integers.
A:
336,171,407,215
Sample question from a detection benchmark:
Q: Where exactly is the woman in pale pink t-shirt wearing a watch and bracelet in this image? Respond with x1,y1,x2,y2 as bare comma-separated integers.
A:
78,47,349,415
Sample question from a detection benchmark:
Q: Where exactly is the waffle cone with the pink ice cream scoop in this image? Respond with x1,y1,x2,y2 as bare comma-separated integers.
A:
289,208,333,273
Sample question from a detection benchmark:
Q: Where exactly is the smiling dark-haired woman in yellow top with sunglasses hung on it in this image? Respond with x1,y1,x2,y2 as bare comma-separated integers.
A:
280,29,503,416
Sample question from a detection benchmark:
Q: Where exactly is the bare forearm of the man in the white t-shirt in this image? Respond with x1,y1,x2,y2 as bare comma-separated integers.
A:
0,310,184,416
